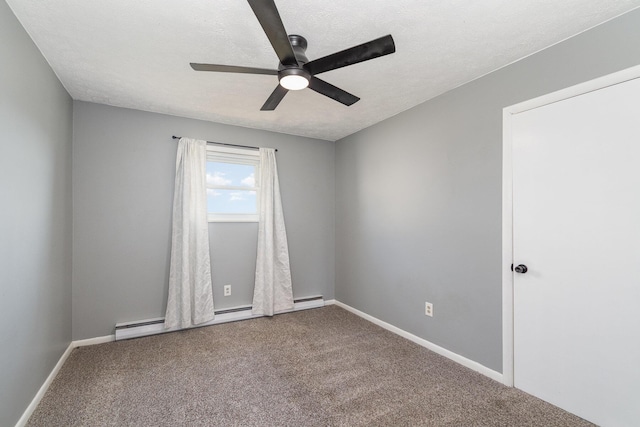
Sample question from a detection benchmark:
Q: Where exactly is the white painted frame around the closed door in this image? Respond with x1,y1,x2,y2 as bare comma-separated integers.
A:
502,65,640,387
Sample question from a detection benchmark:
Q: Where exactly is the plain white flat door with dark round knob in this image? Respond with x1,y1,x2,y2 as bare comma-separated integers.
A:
512,75,640,426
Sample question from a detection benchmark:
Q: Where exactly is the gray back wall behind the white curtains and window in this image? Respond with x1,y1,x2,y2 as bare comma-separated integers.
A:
73,102,335,340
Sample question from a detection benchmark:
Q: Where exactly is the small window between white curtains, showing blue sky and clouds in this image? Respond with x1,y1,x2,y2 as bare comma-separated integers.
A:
207,146,260,222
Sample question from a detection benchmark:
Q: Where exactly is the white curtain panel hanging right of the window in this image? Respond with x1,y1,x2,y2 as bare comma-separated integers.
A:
252,148,293,316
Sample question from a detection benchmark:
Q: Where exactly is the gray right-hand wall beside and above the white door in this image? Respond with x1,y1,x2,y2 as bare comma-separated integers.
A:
336,10,640,372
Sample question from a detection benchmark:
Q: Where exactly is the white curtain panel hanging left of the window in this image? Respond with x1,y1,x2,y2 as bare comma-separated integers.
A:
164,138,214,329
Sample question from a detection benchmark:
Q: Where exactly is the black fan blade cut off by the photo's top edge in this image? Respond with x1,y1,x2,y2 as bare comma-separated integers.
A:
247,0,298,66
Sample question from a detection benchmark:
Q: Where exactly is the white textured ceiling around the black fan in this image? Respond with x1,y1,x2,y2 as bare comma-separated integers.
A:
7,0,640,141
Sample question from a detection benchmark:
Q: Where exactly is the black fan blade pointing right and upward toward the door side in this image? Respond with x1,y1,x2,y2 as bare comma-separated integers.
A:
304,35,396,74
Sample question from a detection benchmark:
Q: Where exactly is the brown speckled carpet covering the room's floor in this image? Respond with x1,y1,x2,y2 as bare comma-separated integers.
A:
28,306,591,427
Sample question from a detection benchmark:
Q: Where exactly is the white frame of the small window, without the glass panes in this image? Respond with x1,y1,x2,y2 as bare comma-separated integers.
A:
206,144,260,222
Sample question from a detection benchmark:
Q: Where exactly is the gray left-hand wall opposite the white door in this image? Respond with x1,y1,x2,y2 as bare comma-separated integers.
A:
0,1,72,426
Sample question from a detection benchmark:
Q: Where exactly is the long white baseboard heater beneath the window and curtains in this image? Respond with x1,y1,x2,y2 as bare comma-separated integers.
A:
115,296,324,341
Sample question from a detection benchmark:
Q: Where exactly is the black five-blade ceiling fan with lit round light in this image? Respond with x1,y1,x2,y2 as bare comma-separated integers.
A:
191,0,396,111
